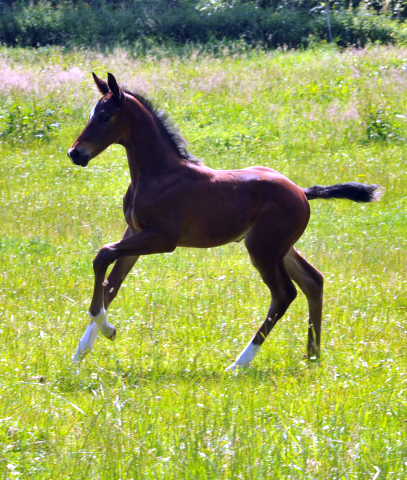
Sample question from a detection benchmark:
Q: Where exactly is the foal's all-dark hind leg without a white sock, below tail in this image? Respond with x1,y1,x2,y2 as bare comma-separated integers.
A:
284,247,324,358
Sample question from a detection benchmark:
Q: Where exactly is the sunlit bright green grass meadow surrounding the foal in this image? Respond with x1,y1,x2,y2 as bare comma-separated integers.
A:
0,43,407,480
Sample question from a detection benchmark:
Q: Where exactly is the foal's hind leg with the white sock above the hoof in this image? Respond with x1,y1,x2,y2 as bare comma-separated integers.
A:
227,226,297,370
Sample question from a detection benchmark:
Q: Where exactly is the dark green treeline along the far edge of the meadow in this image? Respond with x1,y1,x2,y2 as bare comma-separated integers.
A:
0,0,407,48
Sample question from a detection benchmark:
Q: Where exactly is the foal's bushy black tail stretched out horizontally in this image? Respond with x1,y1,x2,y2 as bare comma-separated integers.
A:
304,182,383,202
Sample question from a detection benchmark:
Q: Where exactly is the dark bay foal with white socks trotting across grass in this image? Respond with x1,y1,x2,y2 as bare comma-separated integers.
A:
68,73,380,369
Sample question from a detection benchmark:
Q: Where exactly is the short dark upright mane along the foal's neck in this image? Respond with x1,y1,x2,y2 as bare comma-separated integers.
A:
123,90,201,163
